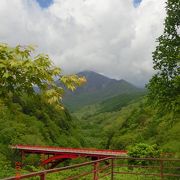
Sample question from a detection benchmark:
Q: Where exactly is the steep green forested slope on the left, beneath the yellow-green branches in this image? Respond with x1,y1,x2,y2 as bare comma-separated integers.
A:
0,95,81,179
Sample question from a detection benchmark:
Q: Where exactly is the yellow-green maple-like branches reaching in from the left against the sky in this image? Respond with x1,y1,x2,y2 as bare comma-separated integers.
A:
0,44,86,108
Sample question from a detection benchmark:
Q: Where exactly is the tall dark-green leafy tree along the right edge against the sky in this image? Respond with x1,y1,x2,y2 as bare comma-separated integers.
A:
147,0,180,111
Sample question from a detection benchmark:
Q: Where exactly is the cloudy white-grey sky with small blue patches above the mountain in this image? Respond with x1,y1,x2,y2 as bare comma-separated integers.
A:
0,0,166,86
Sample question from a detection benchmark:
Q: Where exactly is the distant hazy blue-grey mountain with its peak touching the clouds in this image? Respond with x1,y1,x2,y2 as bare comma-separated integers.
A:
64,71,144,111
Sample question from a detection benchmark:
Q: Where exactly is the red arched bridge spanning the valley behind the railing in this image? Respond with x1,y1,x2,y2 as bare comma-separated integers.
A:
11,145,127,168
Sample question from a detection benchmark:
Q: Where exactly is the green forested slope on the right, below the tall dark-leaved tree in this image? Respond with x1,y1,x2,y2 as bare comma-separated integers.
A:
104,100,180,155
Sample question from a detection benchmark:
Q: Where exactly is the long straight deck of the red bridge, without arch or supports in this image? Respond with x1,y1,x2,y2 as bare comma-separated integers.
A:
11,145,127,157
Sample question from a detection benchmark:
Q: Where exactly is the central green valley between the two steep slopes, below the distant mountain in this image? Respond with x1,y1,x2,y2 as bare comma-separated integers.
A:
74,93,144,149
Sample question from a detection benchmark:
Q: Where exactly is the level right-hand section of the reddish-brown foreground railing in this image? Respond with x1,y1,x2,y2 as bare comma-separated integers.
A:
113,157,180,179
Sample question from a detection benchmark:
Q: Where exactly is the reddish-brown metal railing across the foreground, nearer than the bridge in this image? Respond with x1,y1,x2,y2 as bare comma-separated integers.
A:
4,157,180,180
